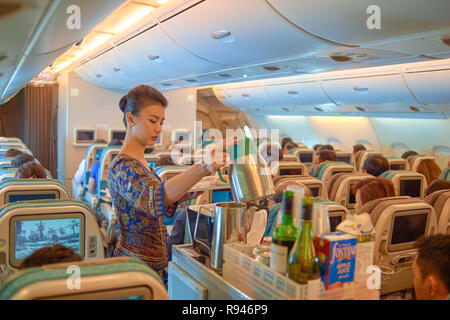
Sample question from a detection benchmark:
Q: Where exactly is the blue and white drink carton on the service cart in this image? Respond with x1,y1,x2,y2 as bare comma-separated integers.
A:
314,232,358,290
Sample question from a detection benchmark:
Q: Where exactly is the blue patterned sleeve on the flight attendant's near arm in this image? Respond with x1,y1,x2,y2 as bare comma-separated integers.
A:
108,161,178,217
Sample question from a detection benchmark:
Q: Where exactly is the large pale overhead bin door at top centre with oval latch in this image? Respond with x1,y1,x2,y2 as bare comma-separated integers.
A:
156,0,331,66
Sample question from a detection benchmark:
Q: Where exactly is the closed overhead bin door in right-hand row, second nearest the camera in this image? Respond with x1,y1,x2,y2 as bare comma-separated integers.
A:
321,74,417,106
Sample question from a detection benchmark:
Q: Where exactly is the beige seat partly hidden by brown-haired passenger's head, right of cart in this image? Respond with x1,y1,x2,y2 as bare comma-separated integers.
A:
329,172,373,212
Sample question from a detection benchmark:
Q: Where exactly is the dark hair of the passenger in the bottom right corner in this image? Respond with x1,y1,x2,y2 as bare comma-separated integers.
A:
415,234,450,291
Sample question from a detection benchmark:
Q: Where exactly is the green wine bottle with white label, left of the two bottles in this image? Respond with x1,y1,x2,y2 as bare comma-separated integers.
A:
270,190,298,274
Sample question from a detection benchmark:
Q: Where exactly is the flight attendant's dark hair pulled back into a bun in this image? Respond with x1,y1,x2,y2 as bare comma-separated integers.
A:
119,85,167,128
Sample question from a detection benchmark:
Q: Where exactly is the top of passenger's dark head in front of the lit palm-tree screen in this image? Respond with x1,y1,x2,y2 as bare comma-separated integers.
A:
19,244,83,270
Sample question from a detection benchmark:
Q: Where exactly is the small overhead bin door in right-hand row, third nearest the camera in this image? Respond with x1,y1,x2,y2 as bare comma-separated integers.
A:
266,81,335,106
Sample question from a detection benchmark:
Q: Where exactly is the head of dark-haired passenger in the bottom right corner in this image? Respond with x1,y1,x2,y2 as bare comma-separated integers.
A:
413,234,450,300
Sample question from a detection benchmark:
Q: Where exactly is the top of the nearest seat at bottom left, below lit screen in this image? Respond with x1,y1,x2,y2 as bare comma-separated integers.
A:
0,257,169,300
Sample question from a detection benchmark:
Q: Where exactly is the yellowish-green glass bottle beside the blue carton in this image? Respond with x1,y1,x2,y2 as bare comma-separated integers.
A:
288,197,320,284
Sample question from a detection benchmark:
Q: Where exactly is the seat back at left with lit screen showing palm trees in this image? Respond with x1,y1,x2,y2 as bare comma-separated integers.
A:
0,200,104,270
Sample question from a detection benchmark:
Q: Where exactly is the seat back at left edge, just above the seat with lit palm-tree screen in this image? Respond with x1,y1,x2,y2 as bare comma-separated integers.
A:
0,179,70,207
